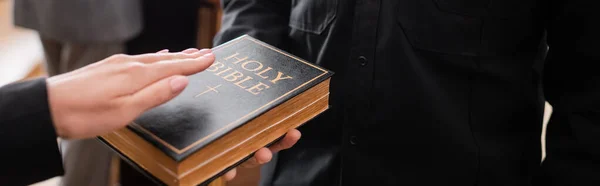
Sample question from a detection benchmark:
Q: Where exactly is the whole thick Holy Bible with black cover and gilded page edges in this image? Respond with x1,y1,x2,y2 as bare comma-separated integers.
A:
99,35,333,185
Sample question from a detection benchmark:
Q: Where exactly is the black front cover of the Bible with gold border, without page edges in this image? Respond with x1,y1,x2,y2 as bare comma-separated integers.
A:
128,35,333,161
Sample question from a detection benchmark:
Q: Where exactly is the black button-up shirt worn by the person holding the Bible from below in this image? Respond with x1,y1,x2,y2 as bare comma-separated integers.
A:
215,0,600,186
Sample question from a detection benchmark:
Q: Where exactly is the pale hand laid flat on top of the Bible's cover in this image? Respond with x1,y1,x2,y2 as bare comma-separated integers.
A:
47,49,214,138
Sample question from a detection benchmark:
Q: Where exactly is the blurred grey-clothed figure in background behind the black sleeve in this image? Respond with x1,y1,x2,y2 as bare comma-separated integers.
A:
14,0,143,186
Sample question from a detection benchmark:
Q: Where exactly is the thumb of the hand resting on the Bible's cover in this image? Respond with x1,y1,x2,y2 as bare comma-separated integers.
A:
130,75,188,113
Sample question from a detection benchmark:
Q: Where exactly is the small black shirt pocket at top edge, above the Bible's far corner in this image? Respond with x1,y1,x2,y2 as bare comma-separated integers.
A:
289,0,338,34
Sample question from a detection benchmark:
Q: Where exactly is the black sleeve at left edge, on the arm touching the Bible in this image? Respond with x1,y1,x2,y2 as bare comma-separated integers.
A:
0,78,63,185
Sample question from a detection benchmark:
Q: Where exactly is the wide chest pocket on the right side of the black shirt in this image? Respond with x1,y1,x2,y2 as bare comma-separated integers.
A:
397,0,538,56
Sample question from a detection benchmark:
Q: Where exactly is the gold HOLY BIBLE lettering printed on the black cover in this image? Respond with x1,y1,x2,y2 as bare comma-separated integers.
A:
206,52,292,95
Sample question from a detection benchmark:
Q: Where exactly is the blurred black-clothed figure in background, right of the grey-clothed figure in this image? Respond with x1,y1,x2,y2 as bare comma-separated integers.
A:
120,0,199,186
